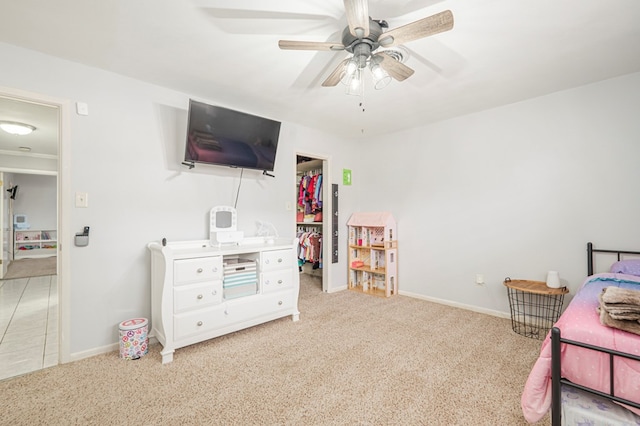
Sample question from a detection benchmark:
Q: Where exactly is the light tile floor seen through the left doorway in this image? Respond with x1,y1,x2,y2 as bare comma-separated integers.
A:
0,275,58,380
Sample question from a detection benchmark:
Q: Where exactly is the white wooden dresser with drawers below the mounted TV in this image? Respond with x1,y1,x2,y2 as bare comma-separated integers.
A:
148,238,300,364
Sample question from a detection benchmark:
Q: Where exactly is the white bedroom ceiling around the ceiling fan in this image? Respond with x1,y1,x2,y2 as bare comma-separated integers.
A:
0,0,640,151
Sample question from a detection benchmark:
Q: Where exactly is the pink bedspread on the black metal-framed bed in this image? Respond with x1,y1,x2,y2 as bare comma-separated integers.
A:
521,273,640,423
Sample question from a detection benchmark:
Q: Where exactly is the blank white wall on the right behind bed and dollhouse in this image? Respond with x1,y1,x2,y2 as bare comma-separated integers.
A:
361,74,640,312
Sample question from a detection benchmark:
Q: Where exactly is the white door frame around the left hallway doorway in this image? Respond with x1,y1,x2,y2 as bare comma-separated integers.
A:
0,86,72,364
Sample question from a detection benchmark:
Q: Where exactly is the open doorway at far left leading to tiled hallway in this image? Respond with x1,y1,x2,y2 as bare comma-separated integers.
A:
0,88,69,379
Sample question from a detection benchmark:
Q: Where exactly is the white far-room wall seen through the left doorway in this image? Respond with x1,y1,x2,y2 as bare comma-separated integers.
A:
12,173,58,230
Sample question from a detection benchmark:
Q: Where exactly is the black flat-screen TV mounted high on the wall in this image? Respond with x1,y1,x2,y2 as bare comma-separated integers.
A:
184,99,280,172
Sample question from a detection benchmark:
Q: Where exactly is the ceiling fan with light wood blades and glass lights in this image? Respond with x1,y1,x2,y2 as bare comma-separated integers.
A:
278,0,453,94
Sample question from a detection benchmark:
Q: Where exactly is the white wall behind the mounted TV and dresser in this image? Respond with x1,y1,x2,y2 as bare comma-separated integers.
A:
0,44,356,358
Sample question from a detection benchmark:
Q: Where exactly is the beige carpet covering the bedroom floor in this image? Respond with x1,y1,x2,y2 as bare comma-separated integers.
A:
0,277,548,426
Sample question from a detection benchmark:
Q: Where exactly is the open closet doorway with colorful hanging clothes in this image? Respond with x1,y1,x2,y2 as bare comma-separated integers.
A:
295,152,332,292
